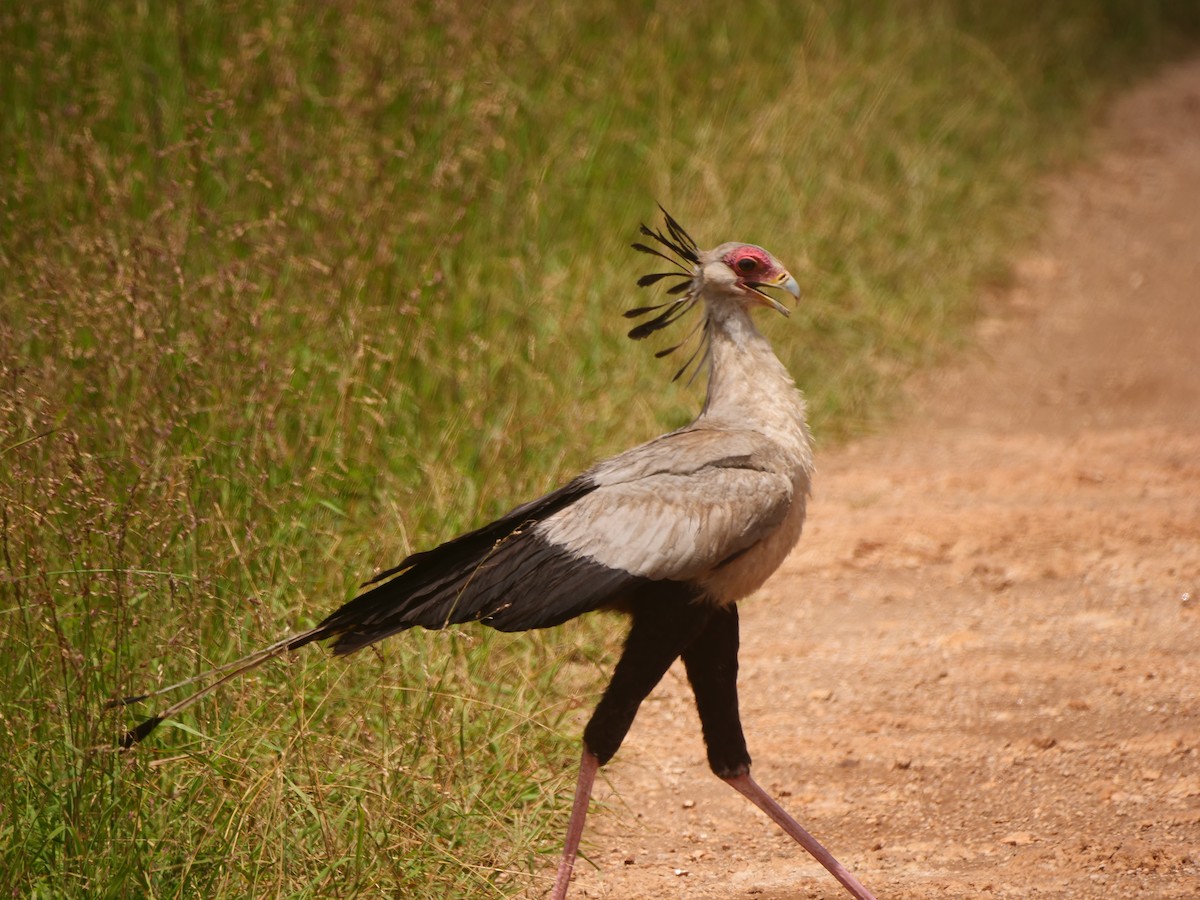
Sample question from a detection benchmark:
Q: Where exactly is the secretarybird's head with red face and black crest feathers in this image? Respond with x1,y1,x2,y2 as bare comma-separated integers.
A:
625,206,800,378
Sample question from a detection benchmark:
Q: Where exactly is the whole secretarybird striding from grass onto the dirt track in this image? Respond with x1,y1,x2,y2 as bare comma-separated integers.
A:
120,212,872,900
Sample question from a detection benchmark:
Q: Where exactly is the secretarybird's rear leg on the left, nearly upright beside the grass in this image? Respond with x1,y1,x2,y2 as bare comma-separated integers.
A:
550,590,712,900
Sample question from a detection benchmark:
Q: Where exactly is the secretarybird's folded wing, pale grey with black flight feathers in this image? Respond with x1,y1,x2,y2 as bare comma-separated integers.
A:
305,430,792,654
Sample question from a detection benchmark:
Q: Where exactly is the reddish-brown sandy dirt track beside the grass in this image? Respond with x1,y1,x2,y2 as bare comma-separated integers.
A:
556,61,1200,900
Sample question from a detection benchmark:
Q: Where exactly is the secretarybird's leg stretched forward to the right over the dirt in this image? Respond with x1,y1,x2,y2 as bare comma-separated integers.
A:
683,606,875,900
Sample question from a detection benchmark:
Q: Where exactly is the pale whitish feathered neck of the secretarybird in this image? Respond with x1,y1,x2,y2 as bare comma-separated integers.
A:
700,306,809,451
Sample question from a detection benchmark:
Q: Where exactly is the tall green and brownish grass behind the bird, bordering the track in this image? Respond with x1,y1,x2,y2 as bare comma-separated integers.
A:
0,0,1200,899
